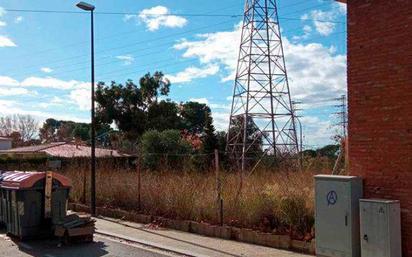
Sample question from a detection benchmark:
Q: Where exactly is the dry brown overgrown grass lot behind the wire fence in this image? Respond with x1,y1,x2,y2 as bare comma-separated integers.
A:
64,158,334,239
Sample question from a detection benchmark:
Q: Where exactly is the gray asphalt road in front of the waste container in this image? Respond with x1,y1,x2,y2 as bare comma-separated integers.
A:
0,234,180,257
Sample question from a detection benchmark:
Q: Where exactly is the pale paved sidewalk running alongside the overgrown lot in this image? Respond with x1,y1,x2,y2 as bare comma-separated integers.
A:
96,218,309,257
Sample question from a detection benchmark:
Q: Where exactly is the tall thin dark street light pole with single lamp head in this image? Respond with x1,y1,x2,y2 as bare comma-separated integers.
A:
76,2,96,216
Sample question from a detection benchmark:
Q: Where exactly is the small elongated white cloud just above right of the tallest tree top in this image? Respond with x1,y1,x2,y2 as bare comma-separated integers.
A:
166,64,219,83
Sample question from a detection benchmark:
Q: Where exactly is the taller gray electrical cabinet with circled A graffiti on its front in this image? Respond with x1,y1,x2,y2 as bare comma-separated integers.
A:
315,175,363,257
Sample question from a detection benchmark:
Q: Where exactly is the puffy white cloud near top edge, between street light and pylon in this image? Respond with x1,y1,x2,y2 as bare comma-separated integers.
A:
137,5,187,31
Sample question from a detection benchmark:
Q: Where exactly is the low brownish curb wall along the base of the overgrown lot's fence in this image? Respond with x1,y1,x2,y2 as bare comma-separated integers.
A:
69,203,315,255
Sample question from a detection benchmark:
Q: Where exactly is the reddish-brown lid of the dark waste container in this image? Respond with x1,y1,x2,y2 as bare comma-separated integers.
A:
0,171,71,189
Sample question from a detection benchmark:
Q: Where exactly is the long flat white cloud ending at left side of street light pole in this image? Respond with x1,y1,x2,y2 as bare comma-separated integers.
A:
20,77,89,90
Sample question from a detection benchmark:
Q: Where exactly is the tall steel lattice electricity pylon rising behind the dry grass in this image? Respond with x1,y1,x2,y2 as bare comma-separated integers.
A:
226,0,299,170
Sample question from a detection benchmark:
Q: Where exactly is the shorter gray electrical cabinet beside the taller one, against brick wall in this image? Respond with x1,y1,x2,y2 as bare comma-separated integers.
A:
360,199,402,257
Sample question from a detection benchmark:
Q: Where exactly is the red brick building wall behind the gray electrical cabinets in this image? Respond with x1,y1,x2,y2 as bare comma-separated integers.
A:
348,0,412,253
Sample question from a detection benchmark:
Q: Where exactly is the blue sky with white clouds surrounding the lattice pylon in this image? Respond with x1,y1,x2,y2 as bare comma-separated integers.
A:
0,0,346,146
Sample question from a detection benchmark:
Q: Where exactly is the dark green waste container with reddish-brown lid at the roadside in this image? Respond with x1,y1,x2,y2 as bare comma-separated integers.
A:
0,171,70,239
